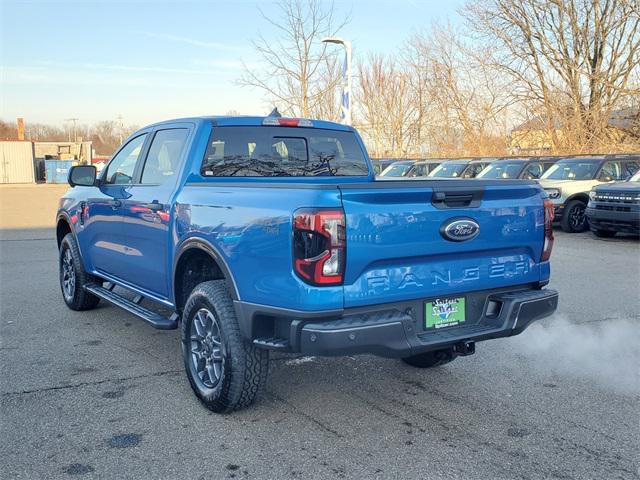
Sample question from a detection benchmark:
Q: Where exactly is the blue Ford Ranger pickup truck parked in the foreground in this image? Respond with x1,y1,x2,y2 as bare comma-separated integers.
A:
57,116,558,412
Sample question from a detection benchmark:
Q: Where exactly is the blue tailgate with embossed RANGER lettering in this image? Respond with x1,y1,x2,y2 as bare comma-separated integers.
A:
340,180,544,308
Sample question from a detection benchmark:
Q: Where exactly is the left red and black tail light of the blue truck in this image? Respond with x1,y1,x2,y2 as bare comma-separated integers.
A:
293,209,346,285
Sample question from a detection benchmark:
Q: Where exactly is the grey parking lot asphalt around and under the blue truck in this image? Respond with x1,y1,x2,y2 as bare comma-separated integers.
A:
0,187,640,479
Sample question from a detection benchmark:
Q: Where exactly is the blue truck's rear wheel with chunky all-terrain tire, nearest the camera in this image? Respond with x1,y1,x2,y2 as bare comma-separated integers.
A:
181,280,269,413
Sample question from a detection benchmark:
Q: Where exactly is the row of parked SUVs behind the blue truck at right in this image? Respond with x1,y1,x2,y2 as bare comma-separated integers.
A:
373,155,640,237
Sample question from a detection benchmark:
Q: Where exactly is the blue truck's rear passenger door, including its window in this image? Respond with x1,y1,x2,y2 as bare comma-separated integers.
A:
122,127,190,299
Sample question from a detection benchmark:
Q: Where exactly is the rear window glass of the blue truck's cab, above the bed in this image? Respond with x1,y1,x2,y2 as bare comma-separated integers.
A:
201,126,369,177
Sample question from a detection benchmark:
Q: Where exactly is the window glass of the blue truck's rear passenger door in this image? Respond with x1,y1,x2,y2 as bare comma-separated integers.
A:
141,128,189,185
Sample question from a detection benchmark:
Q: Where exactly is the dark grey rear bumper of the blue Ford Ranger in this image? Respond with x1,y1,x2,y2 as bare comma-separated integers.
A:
234,289,558,357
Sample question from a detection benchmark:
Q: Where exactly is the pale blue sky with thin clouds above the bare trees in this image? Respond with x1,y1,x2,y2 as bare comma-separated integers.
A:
0,0,463,125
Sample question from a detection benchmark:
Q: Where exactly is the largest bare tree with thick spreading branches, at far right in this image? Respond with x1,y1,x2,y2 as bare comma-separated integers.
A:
465,0,640,151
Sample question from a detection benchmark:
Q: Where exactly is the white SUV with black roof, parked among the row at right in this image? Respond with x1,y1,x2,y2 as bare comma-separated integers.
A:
539,156,640,233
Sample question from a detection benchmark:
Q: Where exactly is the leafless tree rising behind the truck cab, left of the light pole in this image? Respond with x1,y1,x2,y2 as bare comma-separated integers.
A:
238,0,346,120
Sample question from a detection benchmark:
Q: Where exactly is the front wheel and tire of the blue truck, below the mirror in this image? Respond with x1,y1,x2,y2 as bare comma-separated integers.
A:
58,233,102,310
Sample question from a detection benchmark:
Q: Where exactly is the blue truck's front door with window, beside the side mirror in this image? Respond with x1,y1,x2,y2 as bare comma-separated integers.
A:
78,133,147,276
